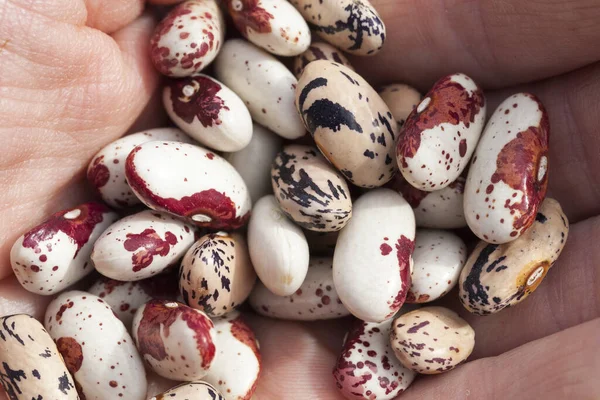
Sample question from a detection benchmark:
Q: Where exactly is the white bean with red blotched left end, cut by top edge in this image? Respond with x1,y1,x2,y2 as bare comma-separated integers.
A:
225,0,310,56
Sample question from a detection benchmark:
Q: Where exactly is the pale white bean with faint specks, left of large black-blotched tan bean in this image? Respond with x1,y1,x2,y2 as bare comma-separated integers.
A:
215,39,305,139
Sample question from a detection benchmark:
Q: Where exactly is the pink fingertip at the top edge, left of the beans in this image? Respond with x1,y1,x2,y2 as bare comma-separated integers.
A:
85,0,144,33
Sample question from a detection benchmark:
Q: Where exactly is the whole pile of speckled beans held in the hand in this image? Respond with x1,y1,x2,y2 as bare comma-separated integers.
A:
0,0,569,400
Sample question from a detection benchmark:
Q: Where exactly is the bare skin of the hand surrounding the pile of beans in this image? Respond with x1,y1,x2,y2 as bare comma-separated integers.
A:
0,0,600,400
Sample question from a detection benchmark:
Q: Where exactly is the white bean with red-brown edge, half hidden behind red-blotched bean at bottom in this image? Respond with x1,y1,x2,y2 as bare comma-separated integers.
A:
202,311,262,400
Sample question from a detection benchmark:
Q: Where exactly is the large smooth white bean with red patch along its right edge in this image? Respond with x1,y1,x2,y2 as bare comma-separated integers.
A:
333,189,415,322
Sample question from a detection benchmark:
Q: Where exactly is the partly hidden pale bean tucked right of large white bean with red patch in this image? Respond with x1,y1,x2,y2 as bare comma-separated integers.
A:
406,229,467,303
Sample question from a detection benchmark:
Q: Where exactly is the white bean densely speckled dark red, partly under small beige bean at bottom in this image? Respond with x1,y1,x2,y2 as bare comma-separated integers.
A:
333,306,417,400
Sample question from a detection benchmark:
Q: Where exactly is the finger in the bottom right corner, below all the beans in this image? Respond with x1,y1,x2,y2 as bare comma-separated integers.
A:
399,319,600,400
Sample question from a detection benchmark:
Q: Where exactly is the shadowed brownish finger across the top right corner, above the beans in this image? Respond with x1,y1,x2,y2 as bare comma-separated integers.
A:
353,0,600,91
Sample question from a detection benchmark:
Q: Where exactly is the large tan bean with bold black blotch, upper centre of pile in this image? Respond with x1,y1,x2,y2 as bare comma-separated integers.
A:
296,60,398,188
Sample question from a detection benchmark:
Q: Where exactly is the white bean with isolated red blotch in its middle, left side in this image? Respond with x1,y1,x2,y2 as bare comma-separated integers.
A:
91,210,195,281
